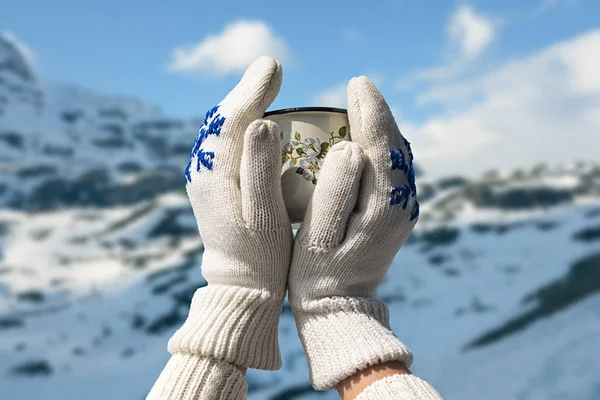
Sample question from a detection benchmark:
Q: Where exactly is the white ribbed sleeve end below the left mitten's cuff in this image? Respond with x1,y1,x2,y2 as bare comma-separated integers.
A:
146,354,248,400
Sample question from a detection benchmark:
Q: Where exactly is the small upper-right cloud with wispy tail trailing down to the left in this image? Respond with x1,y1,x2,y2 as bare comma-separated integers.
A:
396,5,496,90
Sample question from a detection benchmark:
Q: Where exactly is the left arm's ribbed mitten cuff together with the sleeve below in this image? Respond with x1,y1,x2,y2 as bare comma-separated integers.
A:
148,285,281,400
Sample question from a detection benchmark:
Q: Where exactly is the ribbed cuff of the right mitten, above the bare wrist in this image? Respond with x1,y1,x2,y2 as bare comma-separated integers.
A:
294,297,413,390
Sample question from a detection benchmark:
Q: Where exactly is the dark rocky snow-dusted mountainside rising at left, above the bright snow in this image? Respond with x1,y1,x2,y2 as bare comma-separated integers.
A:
0,32,199,210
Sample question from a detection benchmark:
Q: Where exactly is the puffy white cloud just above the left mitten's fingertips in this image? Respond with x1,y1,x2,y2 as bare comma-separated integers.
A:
169,20,290,75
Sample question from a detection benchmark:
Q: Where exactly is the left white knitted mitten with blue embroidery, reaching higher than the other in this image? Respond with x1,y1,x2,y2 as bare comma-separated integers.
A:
150,57,292,399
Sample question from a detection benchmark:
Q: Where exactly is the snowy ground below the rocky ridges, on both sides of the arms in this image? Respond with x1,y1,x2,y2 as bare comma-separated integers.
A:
0,195,600,399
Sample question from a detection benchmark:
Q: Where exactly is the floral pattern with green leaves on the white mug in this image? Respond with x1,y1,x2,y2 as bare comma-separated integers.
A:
280,126,348,185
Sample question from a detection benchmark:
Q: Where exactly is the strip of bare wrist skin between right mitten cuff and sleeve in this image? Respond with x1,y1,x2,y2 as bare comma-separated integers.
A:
337,361,410,400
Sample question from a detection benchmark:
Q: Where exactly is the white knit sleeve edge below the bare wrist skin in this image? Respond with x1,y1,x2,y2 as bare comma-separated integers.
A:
354,374,442,400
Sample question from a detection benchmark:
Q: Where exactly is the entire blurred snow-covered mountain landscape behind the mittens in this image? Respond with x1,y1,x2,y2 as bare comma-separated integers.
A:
0,32,600,400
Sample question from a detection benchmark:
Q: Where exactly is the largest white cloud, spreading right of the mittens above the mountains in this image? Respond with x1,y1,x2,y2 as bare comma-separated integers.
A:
408,30,600,179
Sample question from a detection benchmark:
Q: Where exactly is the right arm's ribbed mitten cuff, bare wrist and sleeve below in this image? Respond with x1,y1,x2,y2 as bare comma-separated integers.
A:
292,297,441,400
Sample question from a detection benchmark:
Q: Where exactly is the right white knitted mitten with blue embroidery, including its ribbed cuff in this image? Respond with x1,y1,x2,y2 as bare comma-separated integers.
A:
288,77,419,390
